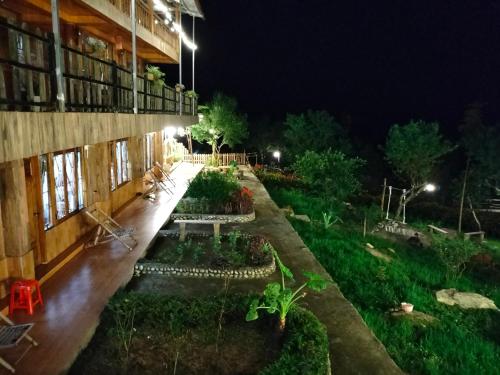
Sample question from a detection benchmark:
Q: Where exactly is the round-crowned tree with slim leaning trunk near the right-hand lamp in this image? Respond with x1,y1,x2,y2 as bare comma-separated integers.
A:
385,120,454,219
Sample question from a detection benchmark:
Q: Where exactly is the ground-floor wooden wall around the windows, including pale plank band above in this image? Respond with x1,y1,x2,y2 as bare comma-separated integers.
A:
0,112,182,298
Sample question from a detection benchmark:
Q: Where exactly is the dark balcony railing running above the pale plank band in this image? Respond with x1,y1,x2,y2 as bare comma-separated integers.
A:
0,20,197,115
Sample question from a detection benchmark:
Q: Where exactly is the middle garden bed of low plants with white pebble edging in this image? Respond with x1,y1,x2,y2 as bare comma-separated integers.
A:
134,231,276,279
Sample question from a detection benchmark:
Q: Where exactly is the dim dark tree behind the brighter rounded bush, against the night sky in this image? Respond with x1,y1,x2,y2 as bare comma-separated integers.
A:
284,110,351,159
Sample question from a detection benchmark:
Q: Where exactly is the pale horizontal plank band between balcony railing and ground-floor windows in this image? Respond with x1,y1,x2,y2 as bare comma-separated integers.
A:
0,112,197,163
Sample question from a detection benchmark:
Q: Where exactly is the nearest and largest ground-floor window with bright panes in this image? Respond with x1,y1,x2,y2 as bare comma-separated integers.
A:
40,149,84,229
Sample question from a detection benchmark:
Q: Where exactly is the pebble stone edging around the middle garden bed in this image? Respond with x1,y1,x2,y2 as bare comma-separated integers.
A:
134,233,276,280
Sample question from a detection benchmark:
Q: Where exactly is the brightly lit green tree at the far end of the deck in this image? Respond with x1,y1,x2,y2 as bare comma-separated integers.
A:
191,93,248,161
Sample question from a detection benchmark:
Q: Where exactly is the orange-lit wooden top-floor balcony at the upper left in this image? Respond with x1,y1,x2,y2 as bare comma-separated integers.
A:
0,0,179,63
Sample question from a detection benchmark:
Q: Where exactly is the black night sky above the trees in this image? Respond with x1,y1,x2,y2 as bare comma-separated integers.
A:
169,0,500,141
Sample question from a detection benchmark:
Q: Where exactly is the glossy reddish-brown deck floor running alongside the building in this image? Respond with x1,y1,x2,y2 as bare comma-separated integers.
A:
0,163,203,375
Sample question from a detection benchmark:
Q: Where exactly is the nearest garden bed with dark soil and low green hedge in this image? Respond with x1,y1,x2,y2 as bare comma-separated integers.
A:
69,292,330,375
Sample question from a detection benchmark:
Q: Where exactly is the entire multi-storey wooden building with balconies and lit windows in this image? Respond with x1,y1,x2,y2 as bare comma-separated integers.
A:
0,0,202,298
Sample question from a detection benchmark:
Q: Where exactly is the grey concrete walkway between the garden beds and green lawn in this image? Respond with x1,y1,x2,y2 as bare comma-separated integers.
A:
134,171,402,375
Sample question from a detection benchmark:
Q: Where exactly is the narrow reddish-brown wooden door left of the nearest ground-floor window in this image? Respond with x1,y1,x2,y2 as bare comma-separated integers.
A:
24,156,47,265
